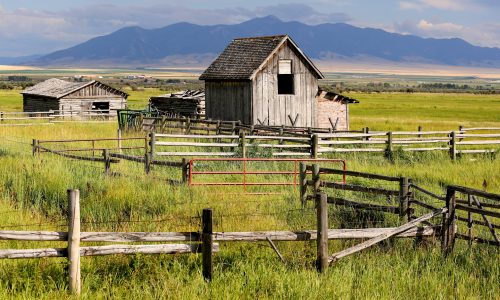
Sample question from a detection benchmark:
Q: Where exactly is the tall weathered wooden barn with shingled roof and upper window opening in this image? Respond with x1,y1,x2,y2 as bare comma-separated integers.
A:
200,35,323,127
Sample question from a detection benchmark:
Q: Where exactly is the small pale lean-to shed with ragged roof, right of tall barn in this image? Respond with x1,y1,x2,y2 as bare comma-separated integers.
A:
316,90,359,131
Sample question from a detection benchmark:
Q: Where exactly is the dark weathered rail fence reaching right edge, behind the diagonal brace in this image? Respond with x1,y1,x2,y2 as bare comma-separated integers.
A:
300,165,500,252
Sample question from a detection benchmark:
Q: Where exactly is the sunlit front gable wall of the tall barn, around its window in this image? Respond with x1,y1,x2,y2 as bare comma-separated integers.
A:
252,42,318,127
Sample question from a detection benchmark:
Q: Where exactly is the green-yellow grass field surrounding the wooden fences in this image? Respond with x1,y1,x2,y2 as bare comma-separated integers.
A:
0,90,500,299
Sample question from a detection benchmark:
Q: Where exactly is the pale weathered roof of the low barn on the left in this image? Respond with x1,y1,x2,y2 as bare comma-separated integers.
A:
21,78,128,99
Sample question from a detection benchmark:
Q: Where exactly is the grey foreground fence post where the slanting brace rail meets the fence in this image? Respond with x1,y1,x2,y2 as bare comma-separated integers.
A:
316,192,328,273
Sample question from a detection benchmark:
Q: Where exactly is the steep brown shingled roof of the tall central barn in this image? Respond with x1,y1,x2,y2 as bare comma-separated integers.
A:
200,35,324,80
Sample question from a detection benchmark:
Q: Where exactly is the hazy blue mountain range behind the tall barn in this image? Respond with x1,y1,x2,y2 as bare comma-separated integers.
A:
35,16,500,67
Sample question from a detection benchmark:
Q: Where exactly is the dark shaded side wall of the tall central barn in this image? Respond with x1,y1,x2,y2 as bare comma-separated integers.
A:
205,81,252,124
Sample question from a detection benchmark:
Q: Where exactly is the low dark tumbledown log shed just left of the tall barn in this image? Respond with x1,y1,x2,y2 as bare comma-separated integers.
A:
149,90,205,119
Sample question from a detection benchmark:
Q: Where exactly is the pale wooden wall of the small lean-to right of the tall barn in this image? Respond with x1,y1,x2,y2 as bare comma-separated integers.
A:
316,100,349,130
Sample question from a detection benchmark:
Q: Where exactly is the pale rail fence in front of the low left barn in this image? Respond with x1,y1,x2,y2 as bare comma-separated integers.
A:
0,110,116,126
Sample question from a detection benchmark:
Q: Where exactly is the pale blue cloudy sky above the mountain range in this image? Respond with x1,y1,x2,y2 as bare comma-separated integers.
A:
0,0,500,57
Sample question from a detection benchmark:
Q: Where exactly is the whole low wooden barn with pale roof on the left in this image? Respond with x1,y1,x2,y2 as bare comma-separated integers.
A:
21,78,128,115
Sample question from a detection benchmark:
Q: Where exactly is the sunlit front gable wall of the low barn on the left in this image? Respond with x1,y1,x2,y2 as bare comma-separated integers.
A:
58,84,127,115
